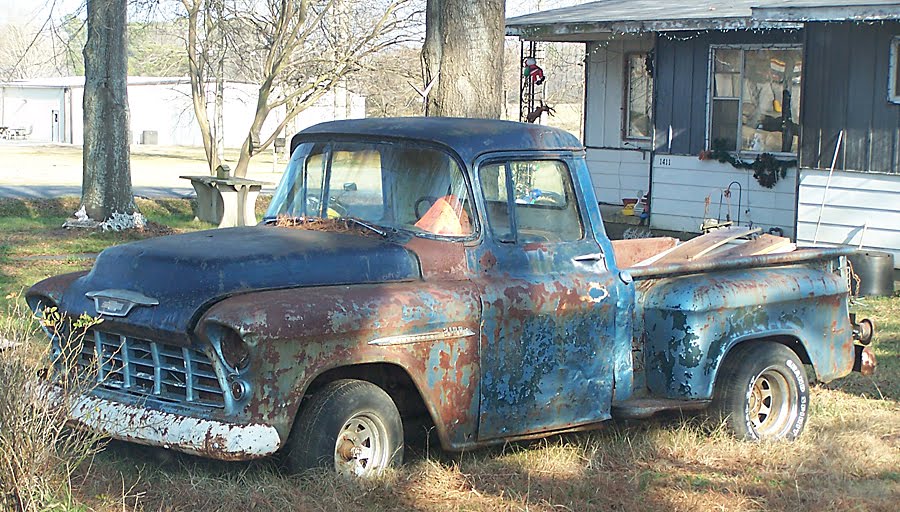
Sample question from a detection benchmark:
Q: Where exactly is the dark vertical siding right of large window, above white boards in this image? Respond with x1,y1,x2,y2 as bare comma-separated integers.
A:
800,22,900,173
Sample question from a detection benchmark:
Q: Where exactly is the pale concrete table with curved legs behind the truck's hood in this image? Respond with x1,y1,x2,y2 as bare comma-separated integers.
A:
180,176,271,228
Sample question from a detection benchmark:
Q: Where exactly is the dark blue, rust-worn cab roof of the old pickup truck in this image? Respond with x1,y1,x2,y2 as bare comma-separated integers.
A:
291,117,584,162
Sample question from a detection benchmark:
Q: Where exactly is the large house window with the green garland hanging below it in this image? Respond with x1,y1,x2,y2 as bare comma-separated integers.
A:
709,46,803,153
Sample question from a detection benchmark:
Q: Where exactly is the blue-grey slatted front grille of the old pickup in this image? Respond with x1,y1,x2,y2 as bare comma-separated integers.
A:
78,329,225,408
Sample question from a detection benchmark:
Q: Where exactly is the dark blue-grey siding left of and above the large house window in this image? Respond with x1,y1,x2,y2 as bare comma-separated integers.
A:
654,30,806,155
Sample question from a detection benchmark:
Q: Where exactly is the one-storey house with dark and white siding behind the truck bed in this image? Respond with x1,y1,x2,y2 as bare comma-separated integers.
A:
507,0,900,266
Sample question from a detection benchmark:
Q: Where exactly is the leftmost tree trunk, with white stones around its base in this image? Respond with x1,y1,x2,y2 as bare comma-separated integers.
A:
81,0,137,221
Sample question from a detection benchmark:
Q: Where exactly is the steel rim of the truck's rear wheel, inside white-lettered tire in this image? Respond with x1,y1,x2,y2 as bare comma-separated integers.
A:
748,367,797,439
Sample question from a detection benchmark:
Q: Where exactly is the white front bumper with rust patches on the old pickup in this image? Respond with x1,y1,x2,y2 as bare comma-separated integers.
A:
60,390,282,460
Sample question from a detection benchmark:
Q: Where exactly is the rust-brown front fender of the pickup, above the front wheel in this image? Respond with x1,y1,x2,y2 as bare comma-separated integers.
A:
198,281,481,447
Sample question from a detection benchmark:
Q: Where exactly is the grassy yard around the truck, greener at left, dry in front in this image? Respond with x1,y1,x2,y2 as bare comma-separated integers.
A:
0,199,900,511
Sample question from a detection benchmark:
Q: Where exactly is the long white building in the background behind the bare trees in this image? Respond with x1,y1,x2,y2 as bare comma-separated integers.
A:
0,76,365,147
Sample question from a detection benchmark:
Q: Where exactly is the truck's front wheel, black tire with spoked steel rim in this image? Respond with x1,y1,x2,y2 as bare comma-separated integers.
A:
286,379,403,478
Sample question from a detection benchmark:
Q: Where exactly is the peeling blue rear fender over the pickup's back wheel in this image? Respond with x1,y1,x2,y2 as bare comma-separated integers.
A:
642,267,854,399
